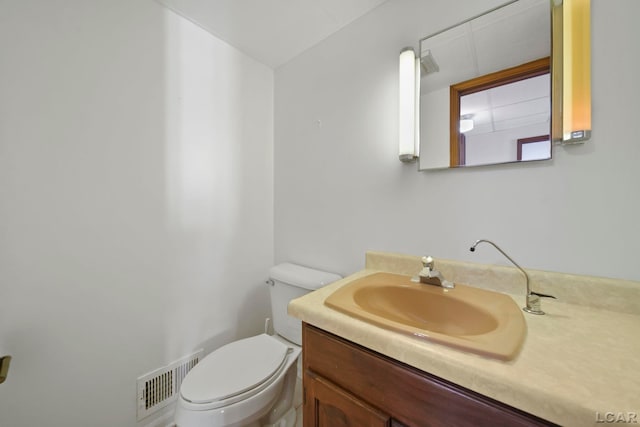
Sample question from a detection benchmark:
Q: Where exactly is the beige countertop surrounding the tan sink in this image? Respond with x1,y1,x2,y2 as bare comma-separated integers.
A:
289,254,640,427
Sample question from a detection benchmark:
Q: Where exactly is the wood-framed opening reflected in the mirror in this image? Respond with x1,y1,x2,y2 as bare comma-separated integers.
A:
449,58,551,167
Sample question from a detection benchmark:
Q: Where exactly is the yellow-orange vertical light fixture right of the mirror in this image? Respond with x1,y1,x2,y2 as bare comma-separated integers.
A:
562,0,591,144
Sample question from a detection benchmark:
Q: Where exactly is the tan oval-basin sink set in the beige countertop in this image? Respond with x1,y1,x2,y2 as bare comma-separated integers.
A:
325,273,527,360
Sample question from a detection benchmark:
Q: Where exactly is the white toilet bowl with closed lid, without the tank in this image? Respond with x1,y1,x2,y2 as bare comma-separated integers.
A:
175,334,301,427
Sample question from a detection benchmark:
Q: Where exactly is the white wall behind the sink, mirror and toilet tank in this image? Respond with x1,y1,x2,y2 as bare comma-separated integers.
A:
275,0,640,280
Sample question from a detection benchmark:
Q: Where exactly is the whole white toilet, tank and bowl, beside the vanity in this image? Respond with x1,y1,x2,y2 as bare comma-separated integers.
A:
170,263,341,427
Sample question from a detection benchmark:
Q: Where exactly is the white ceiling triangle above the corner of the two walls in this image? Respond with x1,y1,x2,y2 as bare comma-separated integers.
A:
157,0,387,68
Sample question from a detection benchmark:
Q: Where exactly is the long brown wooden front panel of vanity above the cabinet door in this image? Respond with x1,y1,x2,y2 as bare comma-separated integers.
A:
302,324,554,427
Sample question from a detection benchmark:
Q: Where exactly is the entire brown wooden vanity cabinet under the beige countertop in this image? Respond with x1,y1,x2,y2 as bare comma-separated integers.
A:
302,323,554,427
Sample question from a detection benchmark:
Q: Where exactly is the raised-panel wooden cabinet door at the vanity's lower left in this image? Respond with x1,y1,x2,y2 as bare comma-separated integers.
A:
302,372,391,427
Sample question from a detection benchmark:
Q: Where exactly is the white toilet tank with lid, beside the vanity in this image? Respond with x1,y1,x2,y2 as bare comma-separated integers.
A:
269,262,342,345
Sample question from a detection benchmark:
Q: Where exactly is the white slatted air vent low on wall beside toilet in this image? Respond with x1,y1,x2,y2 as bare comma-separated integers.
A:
137,349,204,421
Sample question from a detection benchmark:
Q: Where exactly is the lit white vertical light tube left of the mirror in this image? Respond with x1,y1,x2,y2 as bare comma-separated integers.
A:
398,47,420,162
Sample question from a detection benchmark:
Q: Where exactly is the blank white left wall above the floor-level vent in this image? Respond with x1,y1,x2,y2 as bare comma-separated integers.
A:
0,0,273,427
